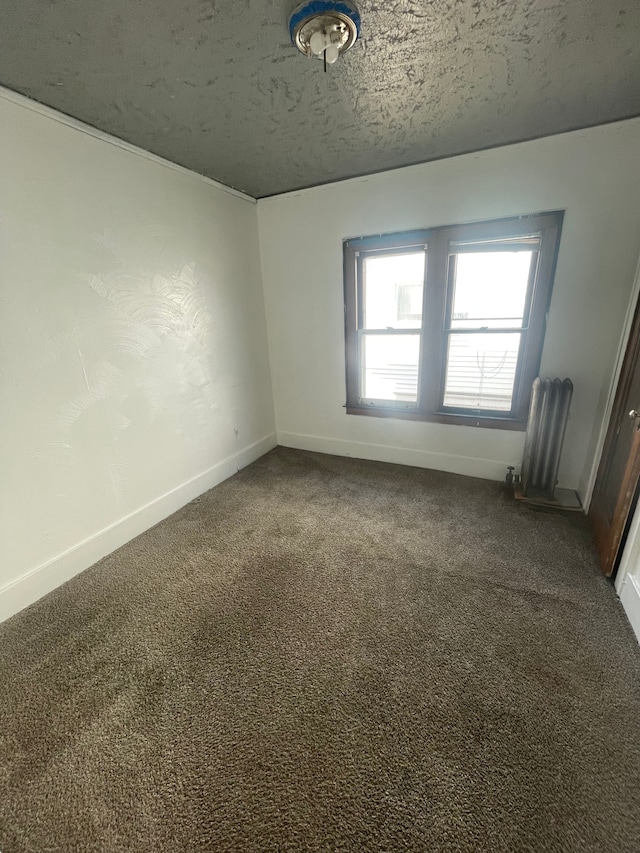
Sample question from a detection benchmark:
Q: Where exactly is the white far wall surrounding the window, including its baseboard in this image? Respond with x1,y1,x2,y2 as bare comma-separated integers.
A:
258,119,640,495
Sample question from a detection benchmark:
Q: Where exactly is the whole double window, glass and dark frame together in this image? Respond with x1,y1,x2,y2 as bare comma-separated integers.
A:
344,211,563,429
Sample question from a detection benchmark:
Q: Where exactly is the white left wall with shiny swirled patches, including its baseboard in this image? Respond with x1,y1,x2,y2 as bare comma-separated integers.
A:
0,91,275,618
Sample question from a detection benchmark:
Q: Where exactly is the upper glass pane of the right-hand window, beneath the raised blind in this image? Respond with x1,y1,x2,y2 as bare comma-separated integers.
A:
451,252,532,329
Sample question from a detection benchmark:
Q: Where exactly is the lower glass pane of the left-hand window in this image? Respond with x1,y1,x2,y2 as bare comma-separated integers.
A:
362,334,420,403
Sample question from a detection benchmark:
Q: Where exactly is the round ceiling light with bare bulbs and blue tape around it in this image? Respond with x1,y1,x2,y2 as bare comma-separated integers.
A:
289,0,360,71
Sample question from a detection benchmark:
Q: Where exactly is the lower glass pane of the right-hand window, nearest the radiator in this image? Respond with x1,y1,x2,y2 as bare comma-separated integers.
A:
443,332,520,412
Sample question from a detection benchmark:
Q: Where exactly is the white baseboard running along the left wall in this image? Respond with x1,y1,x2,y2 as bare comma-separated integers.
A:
0,433,276,622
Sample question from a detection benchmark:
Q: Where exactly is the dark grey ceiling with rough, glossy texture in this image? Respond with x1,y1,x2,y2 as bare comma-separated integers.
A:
0,0,640,197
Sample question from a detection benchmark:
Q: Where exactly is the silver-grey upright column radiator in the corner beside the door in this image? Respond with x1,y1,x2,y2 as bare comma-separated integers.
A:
521,377,573,500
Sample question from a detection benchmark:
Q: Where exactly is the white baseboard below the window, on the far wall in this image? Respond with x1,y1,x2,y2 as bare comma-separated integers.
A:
277,430,506,481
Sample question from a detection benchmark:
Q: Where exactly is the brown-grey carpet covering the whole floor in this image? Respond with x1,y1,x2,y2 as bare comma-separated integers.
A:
0,448,640,853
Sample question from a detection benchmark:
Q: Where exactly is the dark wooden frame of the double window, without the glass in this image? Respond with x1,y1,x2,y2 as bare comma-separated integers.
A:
343,210,564,430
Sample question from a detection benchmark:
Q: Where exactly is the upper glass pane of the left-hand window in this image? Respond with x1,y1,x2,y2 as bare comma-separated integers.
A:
362,251,426,329
